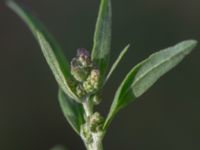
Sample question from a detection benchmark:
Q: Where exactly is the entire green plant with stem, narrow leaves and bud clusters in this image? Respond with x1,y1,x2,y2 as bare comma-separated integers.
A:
7,0,197,150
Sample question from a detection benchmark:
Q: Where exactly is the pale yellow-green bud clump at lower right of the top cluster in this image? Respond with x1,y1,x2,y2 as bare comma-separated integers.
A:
83,69,100,93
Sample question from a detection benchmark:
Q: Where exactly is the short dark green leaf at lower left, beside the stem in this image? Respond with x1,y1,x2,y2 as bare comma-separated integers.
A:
58,89,84,134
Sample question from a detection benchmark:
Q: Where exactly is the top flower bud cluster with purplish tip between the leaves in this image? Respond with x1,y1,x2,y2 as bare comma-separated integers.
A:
71,48,100,98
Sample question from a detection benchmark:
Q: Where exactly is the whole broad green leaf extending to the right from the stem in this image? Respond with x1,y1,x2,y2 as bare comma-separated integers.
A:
104,40,197,129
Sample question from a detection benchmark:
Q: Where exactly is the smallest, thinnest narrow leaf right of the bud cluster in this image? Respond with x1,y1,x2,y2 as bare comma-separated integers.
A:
105,45,130,82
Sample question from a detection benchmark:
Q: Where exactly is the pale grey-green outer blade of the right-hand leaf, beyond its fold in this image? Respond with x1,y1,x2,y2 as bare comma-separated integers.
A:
130,40,197,97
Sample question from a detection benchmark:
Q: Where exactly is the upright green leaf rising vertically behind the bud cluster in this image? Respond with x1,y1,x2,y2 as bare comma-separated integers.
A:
92,0,112,80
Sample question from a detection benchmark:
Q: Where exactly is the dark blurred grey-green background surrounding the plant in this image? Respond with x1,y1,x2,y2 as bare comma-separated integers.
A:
0,0,200,150
